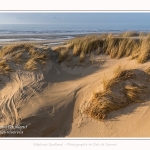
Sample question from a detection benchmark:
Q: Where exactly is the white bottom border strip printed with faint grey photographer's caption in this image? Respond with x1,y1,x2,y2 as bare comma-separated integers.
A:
0,138,150,150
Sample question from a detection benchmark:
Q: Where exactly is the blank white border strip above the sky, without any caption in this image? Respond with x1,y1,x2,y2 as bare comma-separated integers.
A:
0,0,150,11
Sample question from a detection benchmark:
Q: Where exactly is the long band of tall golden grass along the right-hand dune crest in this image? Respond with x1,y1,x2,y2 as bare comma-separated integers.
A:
56,31,150,63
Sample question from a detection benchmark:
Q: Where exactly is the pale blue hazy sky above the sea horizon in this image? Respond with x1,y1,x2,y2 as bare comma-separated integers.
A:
0,12,150,24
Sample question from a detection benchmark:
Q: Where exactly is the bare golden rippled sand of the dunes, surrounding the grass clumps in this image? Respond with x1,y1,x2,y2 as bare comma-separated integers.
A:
0,34,150,138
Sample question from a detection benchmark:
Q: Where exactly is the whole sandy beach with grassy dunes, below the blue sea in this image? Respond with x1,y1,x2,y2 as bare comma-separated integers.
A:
0,33,150,138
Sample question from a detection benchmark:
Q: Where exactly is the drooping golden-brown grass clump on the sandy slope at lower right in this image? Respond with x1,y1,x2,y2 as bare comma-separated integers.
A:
85,66,145,120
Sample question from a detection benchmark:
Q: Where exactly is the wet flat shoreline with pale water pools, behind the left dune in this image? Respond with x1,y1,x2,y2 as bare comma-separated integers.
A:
0,33,86,46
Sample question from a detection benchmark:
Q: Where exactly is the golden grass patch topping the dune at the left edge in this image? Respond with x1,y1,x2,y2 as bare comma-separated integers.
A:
0,43,49,74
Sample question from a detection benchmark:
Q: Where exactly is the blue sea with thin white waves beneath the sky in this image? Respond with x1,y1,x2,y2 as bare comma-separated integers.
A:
0,22,150,42
